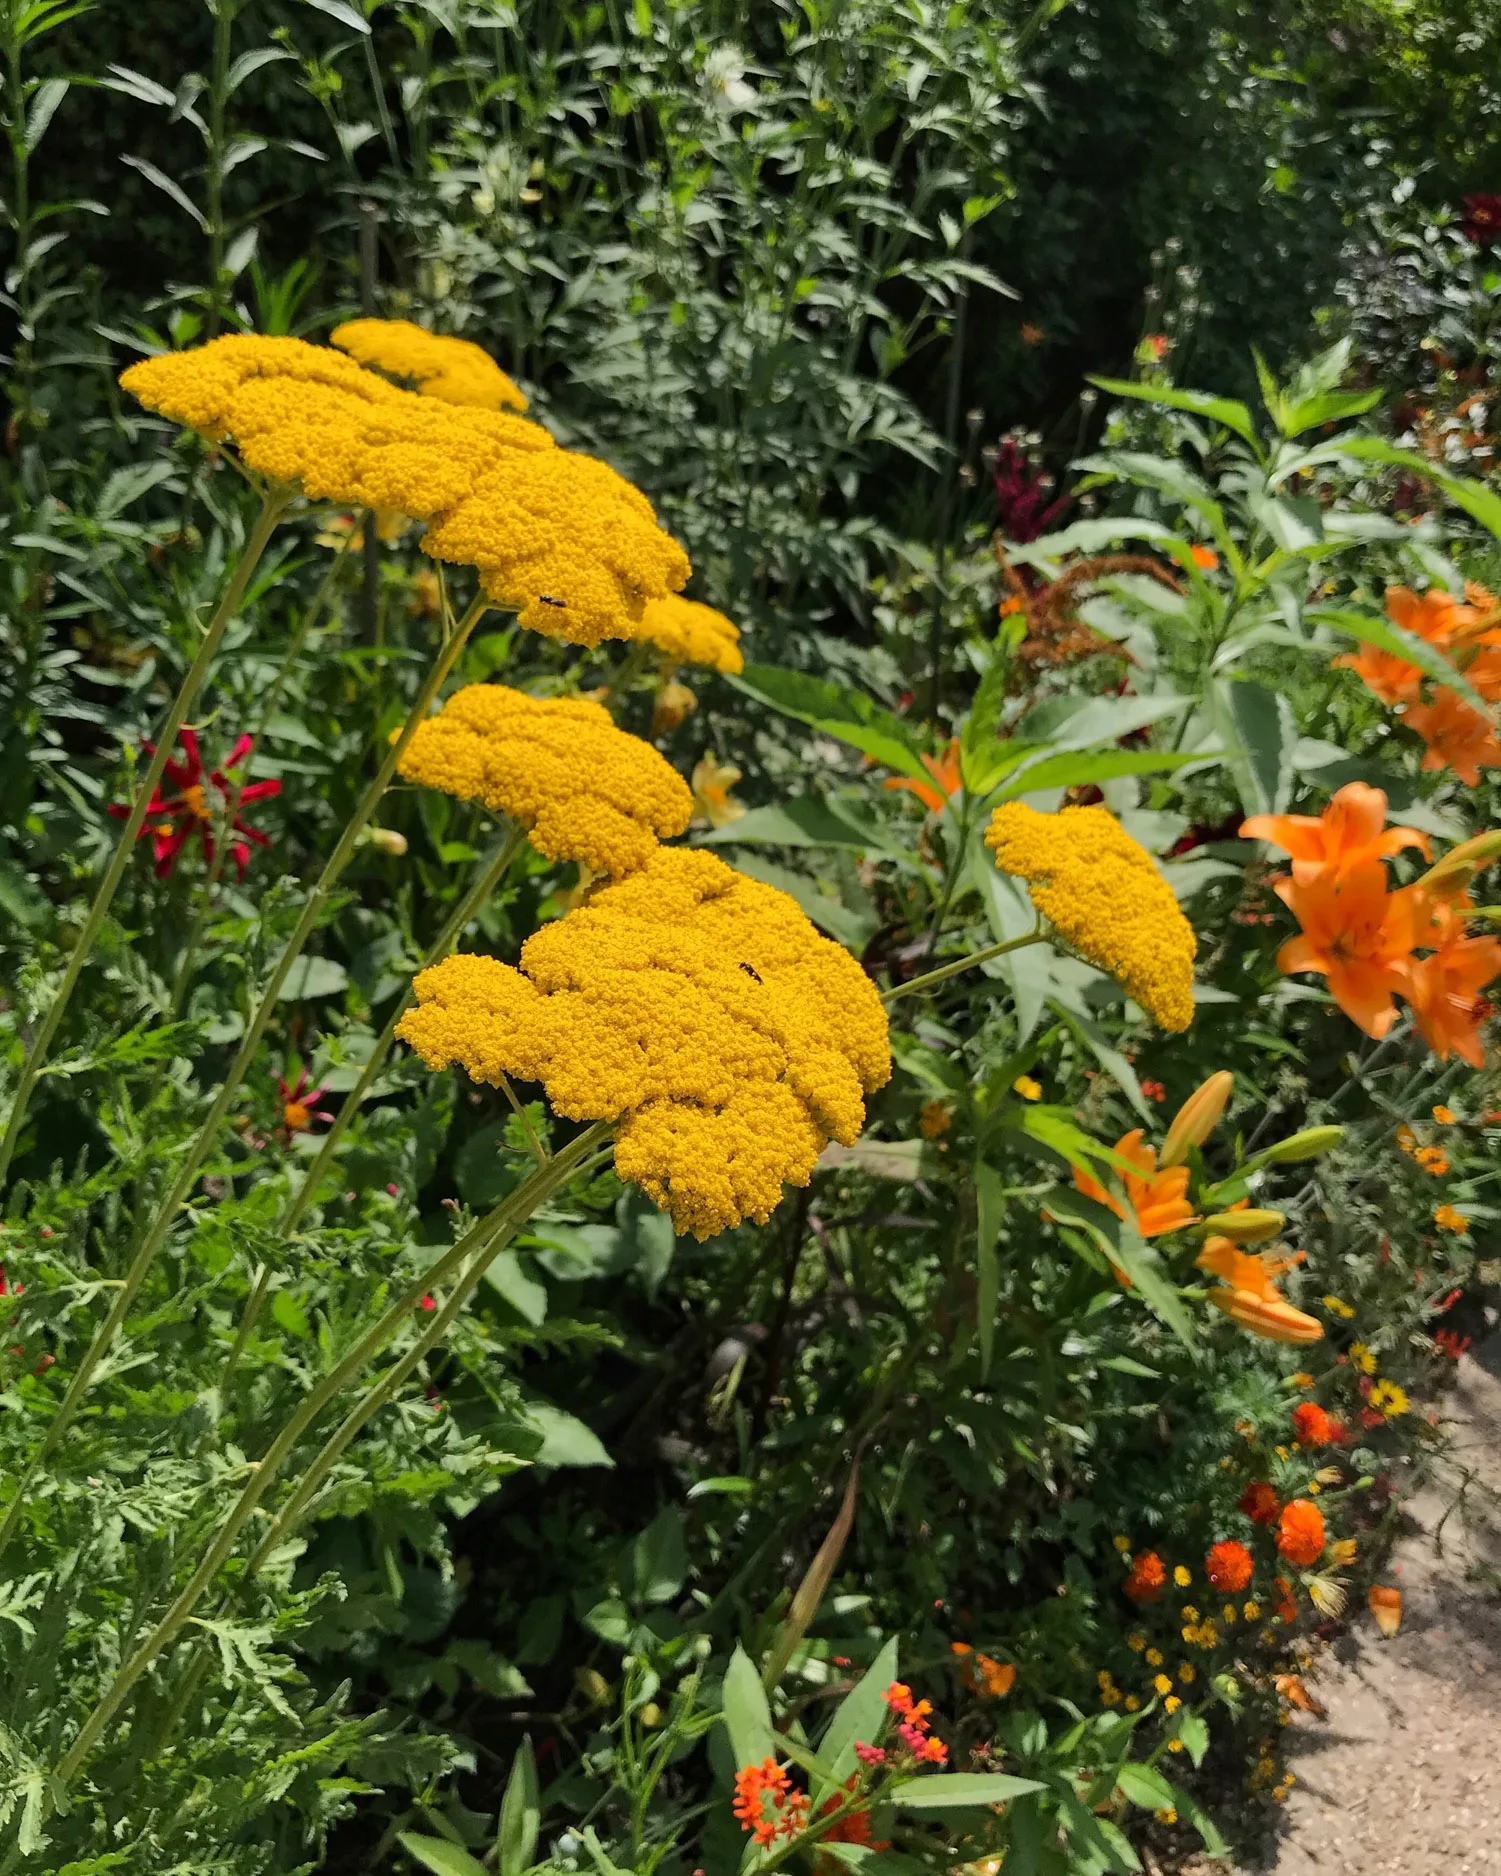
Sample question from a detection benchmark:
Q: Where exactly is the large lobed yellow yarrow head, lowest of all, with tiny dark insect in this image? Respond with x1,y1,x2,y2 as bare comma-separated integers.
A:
400,848,891,1238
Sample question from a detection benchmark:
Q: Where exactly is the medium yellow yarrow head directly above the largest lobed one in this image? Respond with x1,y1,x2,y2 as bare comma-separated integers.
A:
398,685,692,876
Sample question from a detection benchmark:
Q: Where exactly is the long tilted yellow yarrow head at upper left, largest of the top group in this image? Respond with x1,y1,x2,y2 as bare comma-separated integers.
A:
120,334,689,645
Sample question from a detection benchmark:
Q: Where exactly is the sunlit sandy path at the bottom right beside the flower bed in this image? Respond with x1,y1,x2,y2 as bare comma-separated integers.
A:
1199,1334,1501,1876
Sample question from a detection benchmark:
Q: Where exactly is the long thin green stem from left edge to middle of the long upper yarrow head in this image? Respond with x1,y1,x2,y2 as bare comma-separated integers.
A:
0,595,490,1551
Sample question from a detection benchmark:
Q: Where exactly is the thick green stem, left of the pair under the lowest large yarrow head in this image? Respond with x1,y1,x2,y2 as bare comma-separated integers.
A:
51,1120,610,1792
